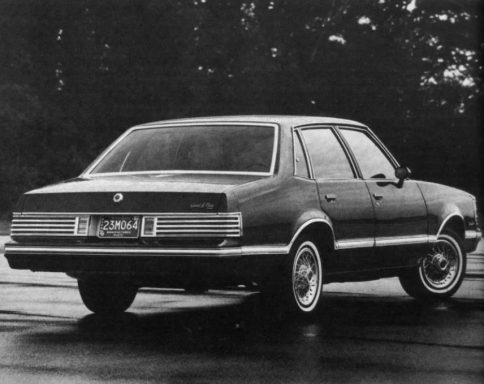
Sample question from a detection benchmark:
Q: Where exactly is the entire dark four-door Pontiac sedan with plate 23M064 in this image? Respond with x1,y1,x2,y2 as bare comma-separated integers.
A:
5,116,481,314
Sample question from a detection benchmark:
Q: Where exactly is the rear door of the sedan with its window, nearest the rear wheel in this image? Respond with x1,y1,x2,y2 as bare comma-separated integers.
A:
300,126,377,272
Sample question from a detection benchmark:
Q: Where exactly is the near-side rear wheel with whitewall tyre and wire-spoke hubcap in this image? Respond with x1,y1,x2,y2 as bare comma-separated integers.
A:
290,237,323,313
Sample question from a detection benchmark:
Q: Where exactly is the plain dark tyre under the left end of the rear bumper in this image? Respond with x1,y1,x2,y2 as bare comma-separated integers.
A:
77,278,138,314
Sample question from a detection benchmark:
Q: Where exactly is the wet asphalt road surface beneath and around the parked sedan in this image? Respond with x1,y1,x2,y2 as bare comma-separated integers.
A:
0,238,484,384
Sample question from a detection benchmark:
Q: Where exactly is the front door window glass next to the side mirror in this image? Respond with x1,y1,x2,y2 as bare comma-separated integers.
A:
340,128,395,179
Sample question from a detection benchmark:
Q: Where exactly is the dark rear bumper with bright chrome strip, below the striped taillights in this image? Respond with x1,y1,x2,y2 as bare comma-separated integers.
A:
5,243,289,287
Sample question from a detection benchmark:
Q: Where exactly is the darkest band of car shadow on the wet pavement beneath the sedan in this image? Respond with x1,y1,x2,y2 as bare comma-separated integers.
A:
21,294,476,355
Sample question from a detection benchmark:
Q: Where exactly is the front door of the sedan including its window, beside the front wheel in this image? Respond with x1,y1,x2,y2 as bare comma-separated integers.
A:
339,127,428,267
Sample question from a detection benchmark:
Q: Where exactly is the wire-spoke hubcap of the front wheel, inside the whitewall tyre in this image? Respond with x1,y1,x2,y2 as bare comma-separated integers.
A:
421,239,461,289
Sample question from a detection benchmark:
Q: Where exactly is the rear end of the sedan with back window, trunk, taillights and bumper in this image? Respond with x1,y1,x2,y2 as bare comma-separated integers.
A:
5,121,279,287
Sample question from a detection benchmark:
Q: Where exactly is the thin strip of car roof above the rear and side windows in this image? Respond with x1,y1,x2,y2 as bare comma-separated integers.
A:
138,115,366,128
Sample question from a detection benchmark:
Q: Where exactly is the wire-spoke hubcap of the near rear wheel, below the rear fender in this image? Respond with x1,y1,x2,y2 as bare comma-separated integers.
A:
292,246,321,307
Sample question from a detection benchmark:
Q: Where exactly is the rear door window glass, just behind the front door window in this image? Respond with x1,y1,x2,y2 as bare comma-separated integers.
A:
302,128,354,179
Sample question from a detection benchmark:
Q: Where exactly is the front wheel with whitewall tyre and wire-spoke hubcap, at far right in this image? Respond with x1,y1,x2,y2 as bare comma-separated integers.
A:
400,230,466,300
